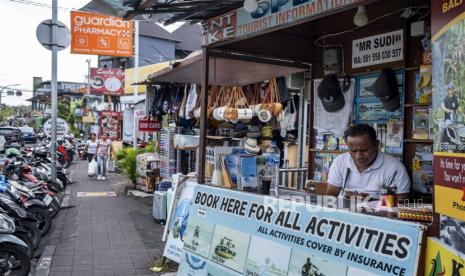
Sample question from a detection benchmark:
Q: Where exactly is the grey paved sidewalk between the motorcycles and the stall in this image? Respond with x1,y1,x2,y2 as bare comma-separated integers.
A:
42,161,176,276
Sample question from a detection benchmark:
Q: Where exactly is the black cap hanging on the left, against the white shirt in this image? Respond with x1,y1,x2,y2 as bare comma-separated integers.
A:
318,74,345,112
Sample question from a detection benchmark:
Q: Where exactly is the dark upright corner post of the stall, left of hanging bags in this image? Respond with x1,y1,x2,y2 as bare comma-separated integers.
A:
197,47,209,184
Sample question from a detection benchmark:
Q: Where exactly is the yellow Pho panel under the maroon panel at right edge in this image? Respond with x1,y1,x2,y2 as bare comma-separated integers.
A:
434,185,465,220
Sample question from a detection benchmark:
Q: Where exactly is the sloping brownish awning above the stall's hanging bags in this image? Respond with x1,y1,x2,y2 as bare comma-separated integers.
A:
147,51,306,86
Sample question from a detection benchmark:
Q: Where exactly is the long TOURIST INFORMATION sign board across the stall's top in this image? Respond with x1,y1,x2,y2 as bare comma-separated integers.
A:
203,0,361,45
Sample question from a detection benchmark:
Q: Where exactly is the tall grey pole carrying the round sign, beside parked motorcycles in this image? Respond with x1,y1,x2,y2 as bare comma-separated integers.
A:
50,0,58,181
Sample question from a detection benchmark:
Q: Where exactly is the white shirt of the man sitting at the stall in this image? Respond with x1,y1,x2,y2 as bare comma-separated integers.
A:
328,152,410,195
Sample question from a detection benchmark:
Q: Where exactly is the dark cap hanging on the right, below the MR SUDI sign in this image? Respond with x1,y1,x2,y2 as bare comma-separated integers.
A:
365,68,400,111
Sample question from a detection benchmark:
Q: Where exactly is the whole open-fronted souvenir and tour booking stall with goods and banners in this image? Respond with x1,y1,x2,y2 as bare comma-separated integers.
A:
92,0,465,275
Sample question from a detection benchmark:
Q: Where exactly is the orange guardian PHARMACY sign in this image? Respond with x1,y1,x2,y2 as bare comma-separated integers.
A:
71,11,133,57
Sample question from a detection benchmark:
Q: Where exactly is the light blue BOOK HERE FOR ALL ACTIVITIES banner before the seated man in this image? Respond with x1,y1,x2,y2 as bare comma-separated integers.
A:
181,185,424,275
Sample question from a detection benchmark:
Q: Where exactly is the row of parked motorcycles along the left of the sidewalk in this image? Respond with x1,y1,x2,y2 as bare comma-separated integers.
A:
0,139,75,276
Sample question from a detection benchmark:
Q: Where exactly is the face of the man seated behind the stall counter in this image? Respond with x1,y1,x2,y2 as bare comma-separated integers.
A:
346,134,378,169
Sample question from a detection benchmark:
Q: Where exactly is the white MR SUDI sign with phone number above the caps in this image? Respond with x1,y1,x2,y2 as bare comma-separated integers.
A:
352,30,404,68
